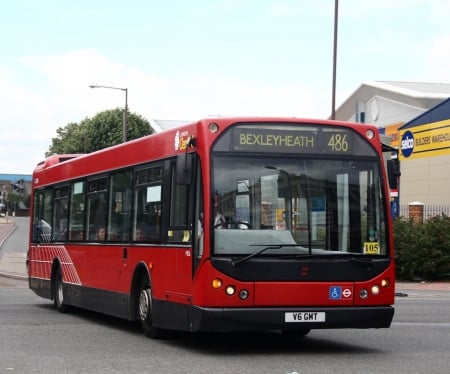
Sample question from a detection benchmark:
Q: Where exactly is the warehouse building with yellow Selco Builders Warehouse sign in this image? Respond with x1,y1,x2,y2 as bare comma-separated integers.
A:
336,82,450,214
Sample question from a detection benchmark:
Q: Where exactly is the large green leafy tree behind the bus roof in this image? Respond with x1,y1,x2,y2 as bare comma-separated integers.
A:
45,108,153,157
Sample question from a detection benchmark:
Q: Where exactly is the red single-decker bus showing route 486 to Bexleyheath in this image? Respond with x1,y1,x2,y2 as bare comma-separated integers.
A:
27,118,395,337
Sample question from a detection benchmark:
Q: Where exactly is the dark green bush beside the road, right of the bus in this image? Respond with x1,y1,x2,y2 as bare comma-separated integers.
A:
394,215,450,280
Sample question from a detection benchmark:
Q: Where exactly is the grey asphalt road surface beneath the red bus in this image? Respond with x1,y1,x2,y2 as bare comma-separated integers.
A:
0,280,450,374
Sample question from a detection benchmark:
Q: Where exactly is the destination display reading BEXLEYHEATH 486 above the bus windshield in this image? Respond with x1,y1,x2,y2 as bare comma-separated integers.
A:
214,124,375,156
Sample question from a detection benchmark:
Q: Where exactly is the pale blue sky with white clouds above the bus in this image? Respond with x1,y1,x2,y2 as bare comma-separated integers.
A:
0,0,450,174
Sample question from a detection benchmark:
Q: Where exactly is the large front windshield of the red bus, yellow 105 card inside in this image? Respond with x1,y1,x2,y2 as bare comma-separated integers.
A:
213,152,388,256
